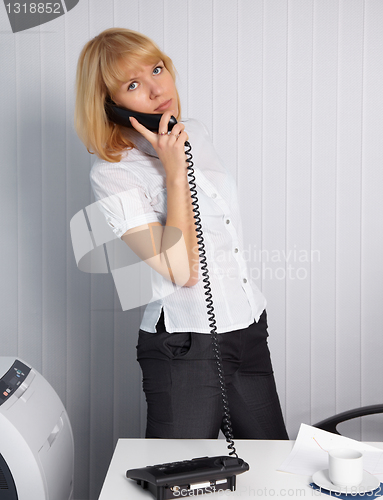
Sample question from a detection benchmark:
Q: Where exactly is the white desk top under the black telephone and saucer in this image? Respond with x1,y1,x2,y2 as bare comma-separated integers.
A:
99,439,383,500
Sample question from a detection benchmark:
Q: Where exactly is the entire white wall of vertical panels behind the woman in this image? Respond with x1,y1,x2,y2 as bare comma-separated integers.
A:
0,0,383,500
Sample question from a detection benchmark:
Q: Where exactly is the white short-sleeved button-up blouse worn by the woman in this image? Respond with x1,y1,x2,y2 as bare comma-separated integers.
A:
90,119,266,333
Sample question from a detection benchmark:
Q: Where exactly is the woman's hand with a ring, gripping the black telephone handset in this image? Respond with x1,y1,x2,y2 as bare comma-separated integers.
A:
130,110,189,177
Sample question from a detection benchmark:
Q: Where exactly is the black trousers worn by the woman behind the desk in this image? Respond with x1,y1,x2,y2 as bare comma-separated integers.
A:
137,311,288,439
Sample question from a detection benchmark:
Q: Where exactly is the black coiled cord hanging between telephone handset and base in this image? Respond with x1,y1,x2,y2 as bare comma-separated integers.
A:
185,141,238,458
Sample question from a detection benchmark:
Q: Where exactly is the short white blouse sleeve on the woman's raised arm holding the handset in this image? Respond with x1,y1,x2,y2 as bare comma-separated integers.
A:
90,161,159,238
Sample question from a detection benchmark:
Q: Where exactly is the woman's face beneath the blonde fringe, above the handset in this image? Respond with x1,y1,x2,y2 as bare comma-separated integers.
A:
112,61,178,116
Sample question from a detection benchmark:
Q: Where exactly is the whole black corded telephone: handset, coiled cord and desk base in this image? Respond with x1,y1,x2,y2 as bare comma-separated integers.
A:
105,99,249,500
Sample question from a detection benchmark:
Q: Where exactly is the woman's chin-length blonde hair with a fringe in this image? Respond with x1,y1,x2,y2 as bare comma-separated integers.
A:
75,28,181,162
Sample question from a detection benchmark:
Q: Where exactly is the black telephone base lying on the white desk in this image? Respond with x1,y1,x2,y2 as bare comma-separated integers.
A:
126,456,249,500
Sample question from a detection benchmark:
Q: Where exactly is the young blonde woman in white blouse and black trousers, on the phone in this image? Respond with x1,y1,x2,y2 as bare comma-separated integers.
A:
76,28,288,439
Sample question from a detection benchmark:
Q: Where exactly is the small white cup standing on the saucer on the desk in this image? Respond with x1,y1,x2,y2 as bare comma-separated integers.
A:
328,448,363,487
